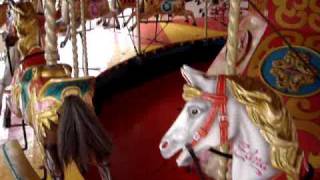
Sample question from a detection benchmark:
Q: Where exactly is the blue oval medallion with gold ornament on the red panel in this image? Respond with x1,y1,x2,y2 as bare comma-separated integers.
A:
260,46,320,97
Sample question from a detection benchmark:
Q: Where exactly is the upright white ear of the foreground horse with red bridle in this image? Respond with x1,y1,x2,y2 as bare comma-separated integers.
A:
181,65,204,87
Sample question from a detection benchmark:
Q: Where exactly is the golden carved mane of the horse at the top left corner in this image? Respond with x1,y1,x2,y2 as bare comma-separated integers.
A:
11,2,40,59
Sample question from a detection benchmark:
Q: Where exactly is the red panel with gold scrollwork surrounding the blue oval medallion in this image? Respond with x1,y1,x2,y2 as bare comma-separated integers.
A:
246,0,320,172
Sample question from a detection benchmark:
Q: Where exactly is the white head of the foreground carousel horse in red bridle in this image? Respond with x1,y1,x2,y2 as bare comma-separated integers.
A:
160,66,237,166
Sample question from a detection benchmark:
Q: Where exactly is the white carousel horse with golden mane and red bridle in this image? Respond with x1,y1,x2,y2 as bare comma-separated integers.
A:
159,66,312,180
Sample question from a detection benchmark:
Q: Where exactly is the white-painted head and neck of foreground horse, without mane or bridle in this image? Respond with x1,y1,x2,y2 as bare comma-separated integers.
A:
160,66,279,180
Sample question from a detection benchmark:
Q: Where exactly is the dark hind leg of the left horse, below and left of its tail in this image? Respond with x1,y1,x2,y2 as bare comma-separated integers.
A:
45,144,64,180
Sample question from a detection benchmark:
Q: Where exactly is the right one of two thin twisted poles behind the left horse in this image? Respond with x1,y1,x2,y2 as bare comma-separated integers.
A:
80,0,89,76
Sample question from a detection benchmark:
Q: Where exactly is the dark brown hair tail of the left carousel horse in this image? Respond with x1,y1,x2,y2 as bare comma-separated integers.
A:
58,95,112,173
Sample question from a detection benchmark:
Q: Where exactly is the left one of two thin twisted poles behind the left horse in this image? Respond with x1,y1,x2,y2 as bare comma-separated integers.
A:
68,0,79,77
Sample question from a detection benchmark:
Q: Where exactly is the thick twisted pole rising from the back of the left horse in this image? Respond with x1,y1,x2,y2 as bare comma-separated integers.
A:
44,0,59,65
